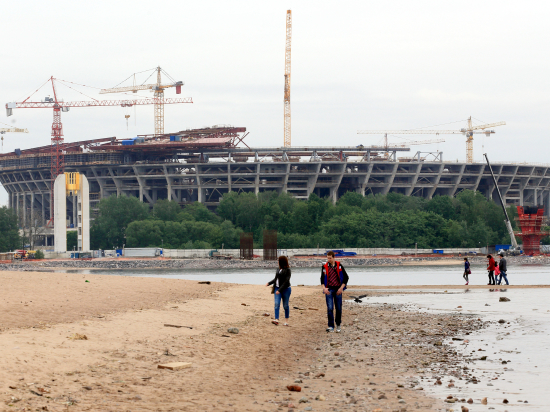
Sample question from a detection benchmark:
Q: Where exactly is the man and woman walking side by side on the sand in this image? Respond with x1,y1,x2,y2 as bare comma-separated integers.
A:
266,251,349,333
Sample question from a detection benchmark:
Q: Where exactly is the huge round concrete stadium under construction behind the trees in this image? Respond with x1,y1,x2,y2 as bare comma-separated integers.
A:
0,125,550,243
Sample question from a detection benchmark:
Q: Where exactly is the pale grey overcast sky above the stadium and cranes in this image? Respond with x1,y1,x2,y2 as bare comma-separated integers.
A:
0,0,550,204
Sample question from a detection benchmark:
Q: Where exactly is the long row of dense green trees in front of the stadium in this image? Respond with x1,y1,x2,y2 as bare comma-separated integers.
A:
91,190,548,249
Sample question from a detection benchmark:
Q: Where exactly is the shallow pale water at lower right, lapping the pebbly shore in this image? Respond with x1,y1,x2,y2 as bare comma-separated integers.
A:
367,288,550,411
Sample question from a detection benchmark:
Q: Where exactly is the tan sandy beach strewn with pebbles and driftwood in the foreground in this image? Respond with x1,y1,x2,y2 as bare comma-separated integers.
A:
0,271,516,411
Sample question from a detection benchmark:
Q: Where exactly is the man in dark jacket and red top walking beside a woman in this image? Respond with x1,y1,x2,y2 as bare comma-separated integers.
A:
321,250,349,333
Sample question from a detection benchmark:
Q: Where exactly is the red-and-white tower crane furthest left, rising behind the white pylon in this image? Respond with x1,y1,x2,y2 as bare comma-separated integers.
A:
6,76,193,225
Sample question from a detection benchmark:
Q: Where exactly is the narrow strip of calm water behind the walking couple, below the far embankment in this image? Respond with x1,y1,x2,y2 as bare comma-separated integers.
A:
60,265,550,286
